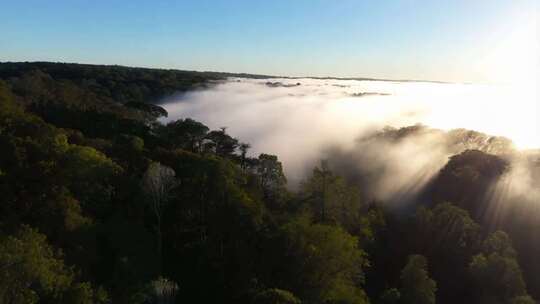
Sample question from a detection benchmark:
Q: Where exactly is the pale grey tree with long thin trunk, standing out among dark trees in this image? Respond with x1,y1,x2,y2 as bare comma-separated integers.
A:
143,162,176,272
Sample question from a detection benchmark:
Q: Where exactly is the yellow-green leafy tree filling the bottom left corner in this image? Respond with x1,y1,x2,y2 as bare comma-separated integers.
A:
0,226,108,304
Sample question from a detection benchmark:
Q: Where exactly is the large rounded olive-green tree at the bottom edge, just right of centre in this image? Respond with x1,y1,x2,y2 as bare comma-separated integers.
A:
281,218,369,303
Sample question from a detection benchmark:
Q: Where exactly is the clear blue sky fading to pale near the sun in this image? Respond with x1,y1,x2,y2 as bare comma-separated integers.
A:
0,0,538,81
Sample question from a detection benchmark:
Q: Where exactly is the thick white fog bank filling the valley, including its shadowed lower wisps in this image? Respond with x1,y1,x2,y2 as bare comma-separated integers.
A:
164,78,540,202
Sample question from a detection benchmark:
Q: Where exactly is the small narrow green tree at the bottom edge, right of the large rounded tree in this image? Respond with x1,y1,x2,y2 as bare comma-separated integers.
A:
401,255,437,304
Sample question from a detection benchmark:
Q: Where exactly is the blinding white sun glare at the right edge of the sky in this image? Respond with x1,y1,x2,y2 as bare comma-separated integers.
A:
481,11,540,149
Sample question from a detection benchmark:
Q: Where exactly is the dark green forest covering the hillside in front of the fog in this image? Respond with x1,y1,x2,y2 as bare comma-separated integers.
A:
0,62,540,304
